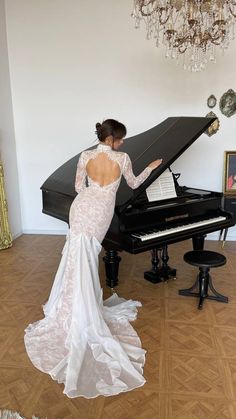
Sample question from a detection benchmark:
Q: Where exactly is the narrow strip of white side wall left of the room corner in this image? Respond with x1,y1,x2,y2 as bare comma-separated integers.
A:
0,0,22,237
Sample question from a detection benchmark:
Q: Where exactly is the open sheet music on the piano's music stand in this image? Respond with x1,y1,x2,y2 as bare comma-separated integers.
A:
146,169,177,202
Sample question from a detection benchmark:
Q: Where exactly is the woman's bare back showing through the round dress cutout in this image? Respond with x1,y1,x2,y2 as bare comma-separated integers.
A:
86,152,121,187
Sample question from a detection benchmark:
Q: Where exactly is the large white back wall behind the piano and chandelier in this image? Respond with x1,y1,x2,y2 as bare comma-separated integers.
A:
3,0,236,238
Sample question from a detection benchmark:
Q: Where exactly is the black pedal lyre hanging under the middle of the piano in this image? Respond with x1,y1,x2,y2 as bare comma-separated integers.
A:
144,246,176,284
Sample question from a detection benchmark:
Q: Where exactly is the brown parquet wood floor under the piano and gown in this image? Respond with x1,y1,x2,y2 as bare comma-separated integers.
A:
0,235,236,419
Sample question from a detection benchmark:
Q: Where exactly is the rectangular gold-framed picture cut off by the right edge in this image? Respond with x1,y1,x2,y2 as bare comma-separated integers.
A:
224,151,236,195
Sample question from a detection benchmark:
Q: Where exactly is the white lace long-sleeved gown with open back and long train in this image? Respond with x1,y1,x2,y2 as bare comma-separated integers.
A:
25,143,151,398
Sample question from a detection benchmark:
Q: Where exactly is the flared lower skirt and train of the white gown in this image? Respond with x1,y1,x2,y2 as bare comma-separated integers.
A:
25,235,146,398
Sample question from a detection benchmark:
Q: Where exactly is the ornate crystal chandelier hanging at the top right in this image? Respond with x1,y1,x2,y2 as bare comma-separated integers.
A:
132,0,236,71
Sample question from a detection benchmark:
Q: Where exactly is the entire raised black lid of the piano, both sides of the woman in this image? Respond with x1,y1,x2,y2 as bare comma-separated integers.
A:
41,117,215,212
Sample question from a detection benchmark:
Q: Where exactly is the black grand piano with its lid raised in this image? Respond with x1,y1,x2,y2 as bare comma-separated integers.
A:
41,117,234,287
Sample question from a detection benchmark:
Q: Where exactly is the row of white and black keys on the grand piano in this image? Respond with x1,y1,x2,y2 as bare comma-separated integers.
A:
132,216,226,241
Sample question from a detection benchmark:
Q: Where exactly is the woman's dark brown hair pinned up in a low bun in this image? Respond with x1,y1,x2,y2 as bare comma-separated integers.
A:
96,119,126,142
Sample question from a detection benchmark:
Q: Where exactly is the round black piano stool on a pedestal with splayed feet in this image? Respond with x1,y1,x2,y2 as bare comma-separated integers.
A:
179,250,228,310
